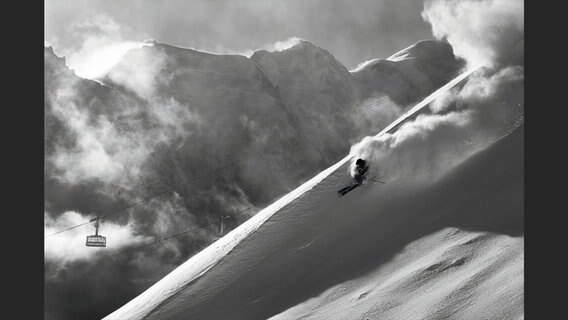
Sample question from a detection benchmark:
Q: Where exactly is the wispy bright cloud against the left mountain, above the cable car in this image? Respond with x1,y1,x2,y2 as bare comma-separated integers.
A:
46,52,200,189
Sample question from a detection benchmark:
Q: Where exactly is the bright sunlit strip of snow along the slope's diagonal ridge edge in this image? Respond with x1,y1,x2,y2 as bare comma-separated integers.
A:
103,67,479,320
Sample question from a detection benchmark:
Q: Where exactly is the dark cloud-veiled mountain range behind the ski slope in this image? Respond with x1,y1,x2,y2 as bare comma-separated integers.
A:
45,41,463,244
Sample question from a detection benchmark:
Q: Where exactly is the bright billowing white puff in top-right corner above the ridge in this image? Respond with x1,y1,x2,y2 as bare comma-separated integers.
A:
422,0,524,68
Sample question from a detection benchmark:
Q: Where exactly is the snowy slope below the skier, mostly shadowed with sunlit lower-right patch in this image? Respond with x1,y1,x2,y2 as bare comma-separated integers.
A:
131,120,523,319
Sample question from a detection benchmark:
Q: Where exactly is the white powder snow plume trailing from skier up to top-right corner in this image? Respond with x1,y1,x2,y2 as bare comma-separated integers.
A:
351,0,524,184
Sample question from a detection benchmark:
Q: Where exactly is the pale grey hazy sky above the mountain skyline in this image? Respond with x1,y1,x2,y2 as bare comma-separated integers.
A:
45,0,434,69
